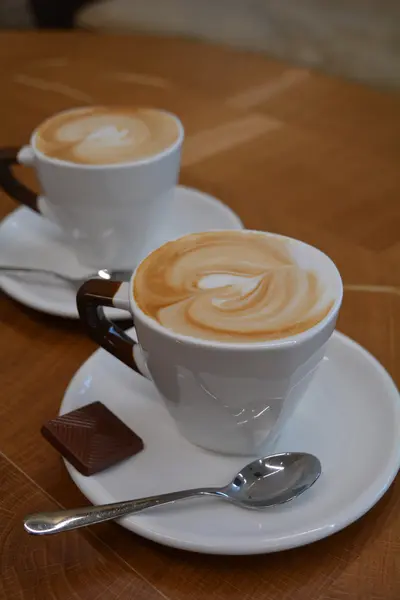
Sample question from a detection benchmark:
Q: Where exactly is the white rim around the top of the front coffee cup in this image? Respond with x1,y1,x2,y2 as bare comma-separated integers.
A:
128,229,343,351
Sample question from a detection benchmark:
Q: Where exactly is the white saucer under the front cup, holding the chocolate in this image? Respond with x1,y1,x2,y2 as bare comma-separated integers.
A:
61,333,400,554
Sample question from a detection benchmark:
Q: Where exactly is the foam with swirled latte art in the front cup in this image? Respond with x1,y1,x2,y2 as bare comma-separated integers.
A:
134,231,333,342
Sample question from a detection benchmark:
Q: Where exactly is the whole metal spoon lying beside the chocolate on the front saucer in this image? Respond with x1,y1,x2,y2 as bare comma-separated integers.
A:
24,452,321,535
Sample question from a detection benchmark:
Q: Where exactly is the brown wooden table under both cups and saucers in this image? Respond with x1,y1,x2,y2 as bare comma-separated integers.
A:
0,33,400,600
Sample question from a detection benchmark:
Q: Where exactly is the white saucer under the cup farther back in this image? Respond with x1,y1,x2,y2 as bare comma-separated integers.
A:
0,186,243,319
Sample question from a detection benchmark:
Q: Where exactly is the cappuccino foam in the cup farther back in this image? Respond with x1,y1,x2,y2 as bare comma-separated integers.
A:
35,106,180,165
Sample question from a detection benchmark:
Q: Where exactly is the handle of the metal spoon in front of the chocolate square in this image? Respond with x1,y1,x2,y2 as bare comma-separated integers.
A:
24,488,220,535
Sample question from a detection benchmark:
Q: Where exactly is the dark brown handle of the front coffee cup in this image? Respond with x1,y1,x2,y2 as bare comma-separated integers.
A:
76,279,141,375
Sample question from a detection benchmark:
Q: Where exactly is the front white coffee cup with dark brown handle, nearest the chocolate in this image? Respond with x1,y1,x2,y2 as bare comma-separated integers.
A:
77,231,343,455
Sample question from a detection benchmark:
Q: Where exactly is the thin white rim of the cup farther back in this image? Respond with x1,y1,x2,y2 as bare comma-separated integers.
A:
29,105,185,171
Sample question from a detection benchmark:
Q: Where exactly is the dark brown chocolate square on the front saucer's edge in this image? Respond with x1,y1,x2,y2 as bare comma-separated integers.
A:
41,402,143,476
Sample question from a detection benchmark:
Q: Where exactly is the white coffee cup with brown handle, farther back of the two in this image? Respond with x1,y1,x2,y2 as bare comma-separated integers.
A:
0,108,184,269
